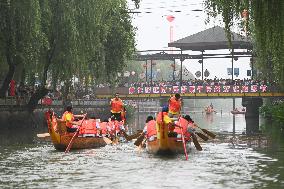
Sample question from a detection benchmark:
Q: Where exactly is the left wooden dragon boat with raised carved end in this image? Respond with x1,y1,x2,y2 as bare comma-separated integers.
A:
45,111,120,151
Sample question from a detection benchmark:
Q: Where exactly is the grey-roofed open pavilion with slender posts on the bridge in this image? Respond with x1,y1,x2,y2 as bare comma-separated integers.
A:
168,26,253,80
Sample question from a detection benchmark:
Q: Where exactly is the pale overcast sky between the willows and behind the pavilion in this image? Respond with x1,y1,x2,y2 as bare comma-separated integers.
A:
129,0,250,79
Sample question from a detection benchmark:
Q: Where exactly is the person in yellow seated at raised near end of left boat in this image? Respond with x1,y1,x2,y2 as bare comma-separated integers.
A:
62,105,85,133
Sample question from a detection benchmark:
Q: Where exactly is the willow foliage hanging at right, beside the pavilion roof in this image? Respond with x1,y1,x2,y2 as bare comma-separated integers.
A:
204,0,284,89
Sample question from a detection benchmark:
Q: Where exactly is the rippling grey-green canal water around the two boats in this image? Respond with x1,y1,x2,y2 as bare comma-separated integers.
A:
0,108,284,189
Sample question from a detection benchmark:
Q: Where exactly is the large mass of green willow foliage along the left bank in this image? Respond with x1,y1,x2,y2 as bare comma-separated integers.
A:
0,0,139,108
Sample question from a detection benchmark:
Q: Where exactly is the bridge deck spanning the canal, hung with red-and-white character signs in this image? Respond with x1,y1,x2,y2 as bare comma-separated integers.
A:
93,85,284,99
